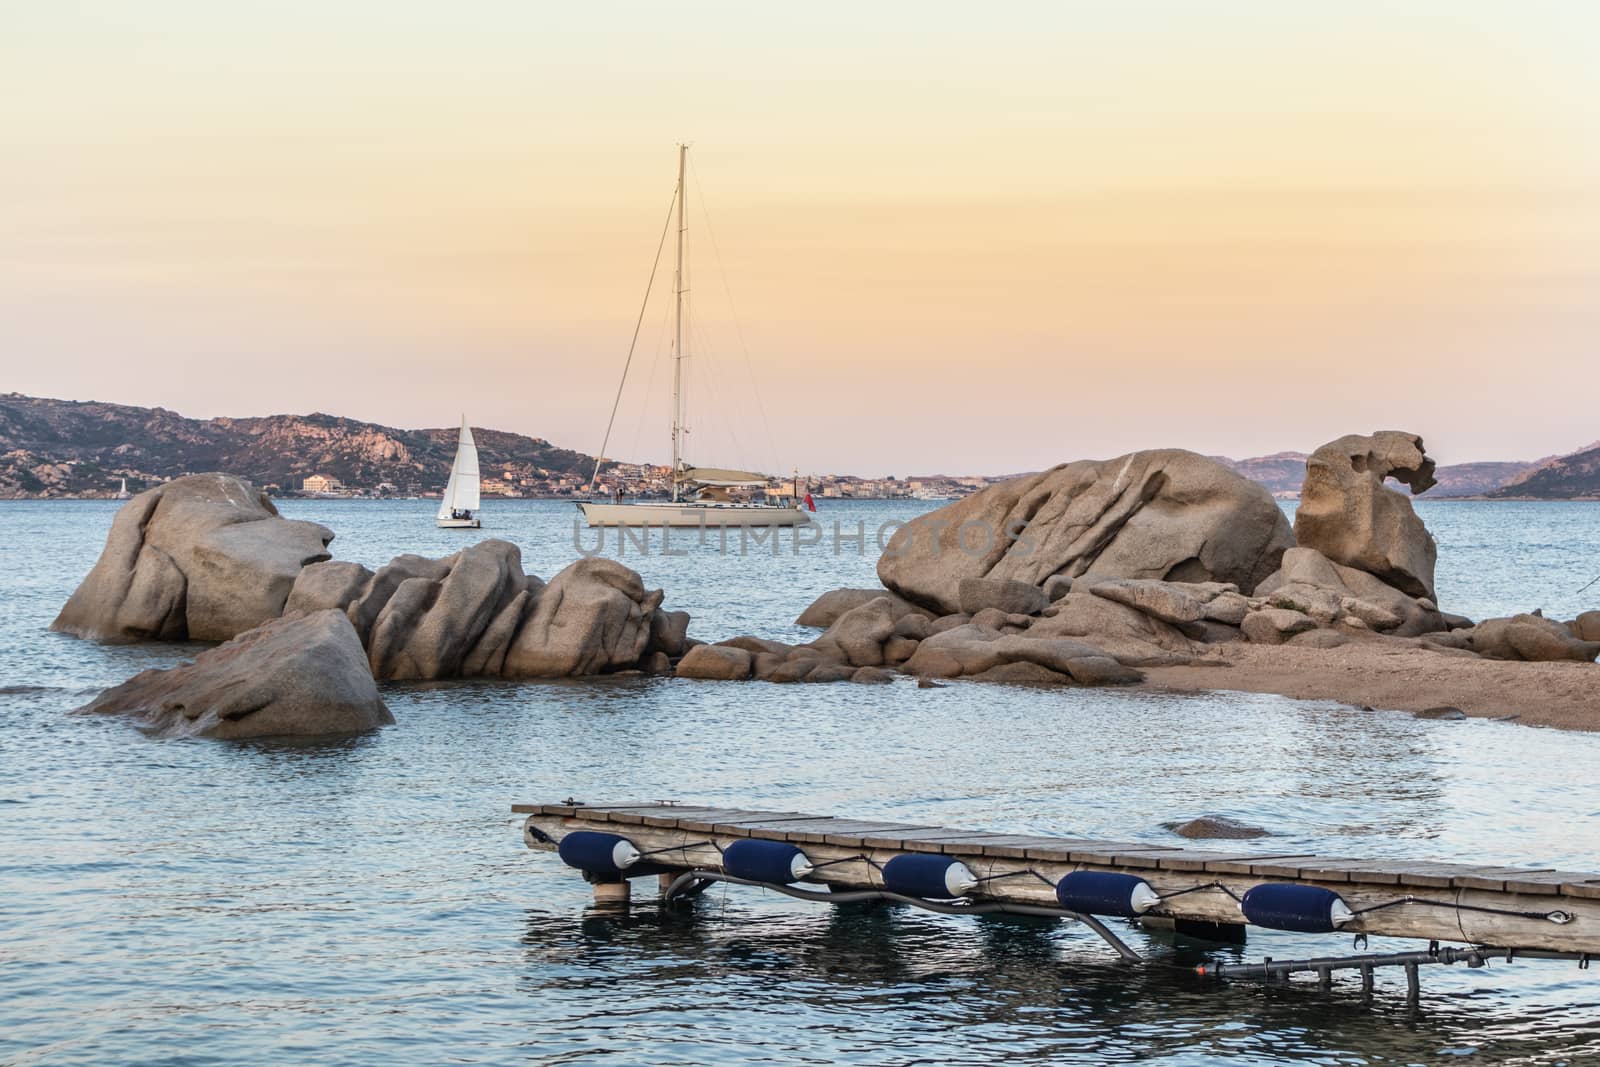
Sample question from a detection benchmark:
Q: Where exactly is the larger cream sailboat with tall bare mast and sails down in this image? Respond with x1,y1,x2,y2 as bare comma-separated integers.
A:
578,144,811,526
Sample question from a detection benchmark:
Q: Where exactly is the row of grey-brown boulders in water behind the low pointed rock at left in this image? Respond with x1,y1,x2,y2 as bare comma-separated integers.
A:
54,475,688,681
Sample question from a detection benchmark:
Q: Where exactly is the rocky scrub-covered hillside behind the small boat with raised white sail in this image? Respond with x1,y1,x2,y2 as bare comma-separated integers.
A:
0,394,594,498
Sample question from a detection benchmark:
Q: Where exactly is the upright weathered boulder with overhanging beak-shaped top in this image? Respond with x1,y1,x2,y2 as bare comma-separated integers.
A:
1294,430,1438,598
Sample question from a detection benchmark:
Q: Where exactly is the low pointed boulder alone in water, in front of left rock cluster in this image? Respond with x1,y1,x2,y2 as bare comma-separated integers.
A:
80,611,394,739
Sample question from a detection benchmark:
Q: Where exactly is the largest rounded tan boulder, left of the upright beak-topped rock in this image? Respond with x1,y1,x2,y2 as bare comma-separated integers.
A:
878,450,1293,614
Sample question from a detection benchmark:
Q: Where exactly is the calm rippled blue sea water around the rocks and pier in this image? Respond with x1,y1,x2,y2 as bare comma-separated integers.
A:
0,501,1600,1064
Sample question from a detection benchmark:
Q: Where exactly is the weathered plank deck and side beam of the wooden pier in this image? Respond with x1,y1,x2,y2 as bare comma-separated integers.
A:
512,801,1600,957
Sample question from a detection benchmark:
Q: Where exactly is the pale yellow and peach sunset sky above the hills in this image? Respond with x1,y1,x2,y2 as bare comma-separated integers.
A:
0,0,1600,475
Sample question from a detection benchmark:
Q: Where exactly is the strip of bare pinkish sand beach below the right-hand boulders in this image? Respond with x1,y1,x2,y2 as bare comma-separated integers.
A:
1136,641,1600,731
